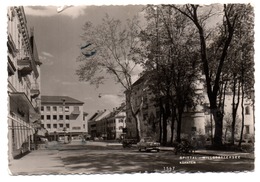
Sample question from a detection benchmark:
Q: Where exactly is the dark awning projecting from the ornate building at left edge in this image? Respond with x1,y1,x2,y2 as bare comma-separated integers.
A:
9,92,40,122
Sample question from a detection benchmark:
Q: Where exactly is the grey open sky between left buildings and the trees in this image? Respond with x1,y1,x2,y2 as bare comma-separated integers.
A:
24,5,142,118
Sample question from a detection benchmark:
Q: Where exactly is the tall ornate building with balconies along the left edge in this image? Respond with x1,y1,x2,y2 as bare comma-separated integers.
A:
7,6,41,159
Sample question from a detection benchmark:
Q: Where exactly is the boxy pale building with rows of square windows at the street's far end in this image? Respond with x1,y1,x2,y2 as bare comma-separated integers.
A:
41,95,87,141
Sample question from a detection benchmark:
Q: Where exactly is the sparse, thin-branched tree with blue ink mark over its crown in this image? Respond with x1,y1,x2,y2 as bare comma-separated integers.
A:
76,15,142,139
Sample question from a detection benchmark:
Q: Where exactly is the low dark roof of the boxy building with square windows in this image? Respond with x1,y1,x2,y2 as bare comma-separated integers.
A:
41,95,84,104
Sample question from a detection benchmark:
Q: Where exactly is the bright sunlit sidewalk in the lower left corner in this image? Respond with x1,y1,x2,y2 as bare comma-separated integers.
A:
9,149,66,175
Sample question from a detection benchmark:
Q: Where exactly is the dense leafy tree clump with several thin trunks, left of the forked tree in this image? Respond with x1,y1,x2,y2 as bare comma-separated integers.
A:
135,5,198,144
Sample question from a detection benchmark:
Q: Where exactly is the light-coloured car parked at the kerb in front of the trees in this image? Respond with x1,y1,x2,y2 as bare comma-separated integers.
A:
137,137,160,152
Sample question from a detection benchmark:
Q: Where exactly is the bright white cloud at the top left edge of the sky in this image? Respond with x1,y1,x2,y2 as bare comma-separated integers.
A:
24,6,86,19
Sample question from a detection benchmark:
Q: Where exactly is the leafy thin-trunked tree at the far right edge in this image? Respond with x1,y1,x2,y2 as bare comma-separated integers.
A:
220,5,254,144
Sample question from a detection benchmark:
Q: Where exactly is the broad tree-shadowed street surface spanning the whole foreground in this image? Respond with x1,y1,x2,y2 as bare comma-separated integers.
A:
10,142,254,175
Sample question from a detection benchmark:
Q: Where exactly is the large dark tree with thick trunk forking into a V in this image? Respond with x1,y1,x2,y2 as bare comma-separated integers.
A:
173,4,252,146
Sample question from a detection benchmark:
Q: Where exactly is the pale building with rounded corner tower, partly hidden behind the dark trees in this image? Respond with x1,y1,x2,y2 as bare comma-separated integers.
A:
126,75,254,143
